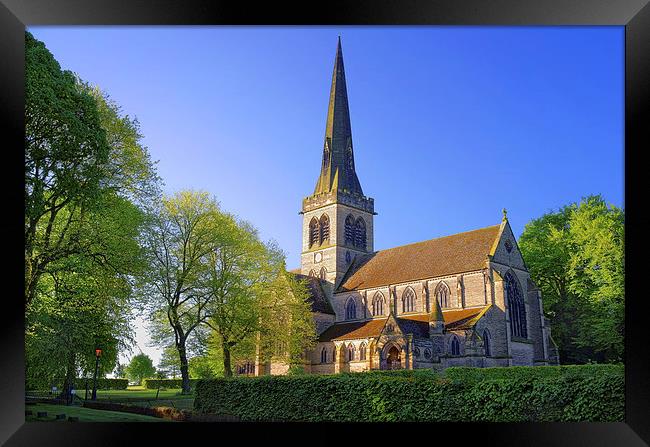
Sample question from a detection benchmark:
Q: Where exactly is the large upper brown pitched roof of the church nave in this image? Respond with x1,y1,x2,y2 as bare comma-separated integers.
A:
337,225,501,292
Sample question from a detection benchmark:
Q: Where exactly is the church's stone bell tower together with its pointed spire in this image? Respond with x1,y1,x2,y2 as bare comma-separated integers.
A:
301,37,375,290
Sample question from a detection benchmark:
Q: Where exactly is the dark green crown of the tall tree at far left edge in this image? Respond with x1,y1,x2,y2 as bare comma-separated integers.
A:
25,32,109,305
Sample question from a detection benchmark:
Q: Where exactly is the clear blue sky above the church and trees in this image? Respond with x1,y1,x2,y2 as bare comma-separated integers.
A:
29,26,624,368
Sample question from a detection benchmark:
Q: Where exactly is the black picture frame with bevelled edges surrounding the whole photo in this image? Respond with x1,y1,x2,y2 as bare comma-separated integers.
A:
0,0,650,446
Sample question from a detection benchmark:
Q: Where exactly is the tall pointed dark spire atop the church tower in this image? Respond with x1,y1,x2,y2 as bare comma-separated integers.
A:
314,36,363,199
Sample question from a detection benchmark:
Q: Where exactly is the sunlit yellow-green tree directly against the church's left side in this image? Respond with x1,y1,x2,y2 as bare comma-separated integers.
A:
205,226,315,377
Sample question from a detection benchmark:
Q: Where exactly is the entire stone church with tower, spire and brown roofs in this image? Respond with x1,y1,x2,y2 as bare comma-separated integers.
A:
241,38,558,375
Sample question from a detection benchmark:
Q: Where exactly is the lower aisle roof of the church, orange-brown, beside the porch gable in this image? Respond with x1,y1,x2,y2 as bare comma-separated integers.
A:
318,306,490,342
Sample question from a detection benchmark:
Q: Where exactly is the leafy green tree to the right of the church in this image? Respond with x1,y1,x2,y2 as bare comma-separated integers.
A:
519,196,625,363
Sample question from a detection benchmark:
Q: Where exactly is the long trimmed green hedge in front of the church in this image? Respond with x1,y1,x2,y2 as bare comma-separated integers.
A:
194,365,625,422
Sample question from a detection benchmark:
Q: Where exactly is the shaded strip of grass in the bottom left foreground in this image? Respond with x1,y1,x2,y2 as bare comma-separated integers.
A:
25,404,172,422
